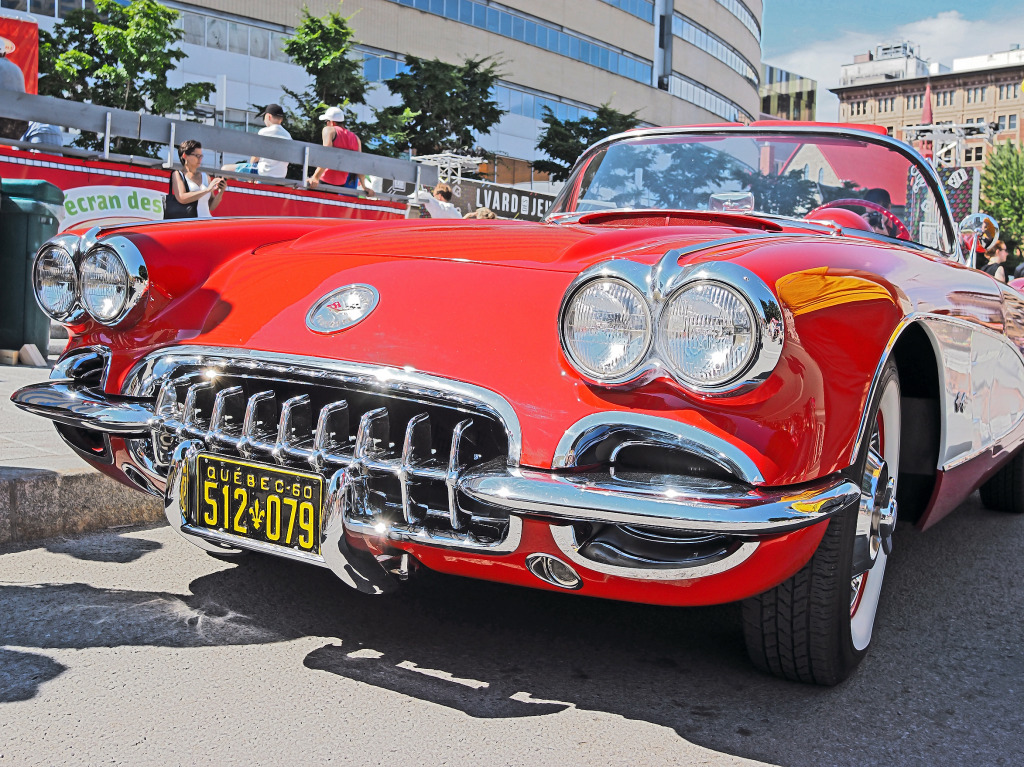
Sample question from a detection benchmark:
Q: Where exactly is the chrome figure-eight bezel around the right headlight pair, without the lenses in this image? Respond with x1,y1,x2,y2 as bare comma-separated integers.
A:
558,256,785,396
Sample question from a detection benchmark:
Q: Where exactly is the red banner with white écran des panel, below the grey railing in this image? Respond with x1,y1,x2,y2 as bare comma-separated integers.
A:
0,146,406,231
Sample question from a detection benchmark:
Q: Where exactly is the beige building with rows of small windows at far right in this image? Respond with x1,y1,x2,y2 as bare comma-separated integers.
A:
831,48,1024,166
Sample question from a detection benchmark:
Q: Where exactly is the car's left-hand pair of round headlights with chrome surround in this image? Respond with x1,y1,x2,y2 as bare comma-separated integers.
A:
32,236,150,327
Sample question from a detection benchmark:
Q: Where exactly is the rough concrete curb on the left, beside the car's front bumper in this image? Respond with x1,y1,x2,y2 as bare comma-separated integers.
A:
0,466,164,544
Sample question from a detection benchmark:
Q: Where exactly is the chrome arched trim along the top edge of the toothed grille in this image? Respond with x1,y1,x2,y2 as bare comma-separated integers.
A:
124,346,522,466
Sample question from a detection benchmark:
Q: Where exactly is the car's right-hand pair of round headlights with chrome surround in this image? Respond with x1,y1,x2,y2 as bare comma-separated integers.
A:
559,260,783,394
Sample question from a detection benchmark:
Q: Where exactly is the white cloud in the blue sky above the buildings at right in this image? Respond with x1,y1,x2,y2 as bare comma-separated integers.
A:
768,10,1024,122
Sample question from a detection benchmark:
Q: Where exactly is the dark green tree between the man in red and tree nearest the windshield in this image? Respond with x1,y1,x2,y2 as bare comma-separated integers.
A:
378,55,504,155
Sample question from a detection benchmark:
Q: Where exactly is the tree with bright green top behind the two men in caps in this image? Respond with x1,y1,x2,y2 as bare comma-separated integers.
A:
285,3,411,156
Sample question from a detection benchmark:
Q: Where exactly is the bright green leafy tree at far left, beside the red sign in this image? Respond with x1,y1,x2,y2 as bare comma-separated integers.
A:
39,0,214,154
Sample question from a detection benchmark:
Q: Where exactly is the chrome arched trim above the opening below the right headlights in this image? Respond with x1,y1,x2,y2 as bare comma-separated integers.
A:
551,411,765,484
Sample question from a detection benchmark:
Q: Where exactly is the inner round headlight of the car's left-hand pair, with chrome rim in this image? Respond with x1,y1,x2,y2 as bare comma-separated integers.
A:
79,238,150,326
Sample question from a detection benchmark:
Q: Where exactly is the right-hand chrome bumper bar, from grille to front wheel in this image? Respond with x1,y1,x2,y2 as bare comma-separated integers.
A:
461,466,860,536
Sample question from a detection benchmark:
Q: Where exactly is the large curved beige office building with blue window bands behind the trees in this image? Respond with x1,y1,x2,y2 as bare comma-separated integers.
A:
6,0,762,182
